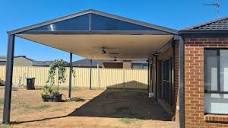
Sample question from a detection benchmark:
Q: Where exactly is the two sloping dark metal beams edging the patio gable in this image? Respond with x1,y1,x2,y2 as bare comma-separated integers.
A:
9,9,177,34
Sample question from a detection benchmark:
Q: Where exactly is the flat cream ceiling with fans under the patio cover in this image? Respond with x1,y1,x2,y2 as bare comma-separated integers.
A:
18,34,172,60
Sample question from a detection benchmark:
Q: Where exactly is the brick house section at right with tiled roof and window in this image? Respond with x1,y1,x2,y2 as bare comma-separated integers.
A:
180,18,228,128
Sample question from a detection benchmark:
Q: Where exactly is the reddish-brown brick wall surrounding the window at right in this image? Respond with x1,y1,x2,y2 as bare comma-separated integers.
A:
185,38,228,128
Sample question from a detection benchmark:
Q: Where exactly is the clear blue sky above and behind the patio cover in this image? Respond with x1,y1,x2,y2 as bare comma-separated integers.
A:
0,0,228,60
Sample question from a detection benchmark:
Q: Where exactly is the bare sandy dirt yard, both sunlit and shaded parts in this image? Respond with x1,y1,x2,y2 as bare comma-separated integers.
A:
0,88,175,128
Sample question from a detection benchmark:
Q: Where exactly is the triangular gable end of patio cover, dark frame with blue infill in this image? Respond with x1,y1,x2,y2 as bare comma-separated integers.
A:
9,10,177,35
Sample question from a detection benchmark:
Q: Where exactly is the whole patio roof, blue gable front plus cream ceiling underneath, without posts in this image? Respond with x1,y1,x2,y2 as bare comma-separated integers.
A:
10,10,176,60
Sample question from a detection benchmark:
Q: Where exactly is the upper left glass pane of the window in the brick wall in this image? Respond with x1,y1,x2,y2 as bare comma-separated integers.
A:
205,50,218,91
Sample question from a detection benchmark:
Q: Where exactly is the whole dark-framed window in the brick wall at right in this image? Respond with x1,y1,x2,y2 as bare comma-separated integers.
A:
205,49,228,114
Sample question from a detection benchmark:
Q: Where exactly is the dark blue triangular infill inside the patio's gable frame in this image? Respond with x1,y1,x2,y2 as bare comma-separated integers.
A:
26,14,167,34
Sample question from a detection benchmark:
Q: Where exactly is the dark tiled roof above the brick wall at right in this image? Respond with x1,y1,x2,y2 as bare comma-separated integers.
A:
179,17,228,34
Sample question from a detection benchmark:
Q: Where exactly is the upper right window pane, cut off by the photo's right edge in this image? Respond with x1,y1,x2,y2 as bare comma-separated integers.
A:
220,50,228,91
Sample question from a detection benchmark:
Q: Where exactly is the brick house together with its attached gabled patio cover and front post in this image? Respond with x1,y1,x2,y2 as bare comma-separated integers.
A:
0,10,228,128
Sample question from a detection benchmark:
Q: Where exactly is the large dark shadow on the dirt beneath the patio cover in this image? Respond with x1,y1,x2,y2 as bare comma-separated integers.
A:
69,81,171,121
